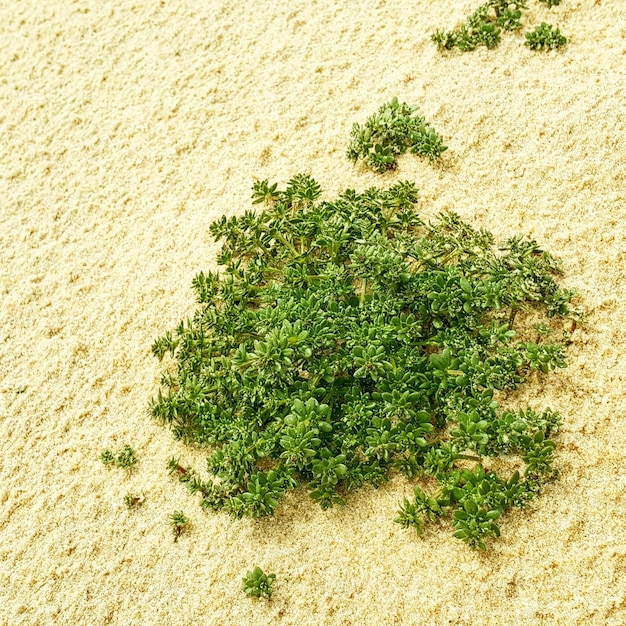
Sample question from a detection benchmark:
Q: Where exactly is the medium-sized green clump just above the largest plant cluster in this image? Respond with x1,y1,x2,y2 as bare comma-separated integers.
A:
346,98,447,171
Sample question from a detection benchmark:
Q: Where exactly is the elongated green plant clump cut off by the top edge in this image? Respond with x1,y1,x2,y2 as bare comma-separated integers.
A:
431,0,528,52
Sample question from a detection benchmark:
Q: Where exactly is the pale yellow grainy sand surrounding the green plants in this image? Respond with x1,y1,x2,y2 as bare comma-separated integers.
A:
0,0,626,626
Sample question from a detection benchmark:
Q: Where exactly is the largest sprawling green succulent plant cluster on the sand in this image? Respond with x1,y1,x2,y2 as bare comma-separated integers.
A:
150,175,576,547
